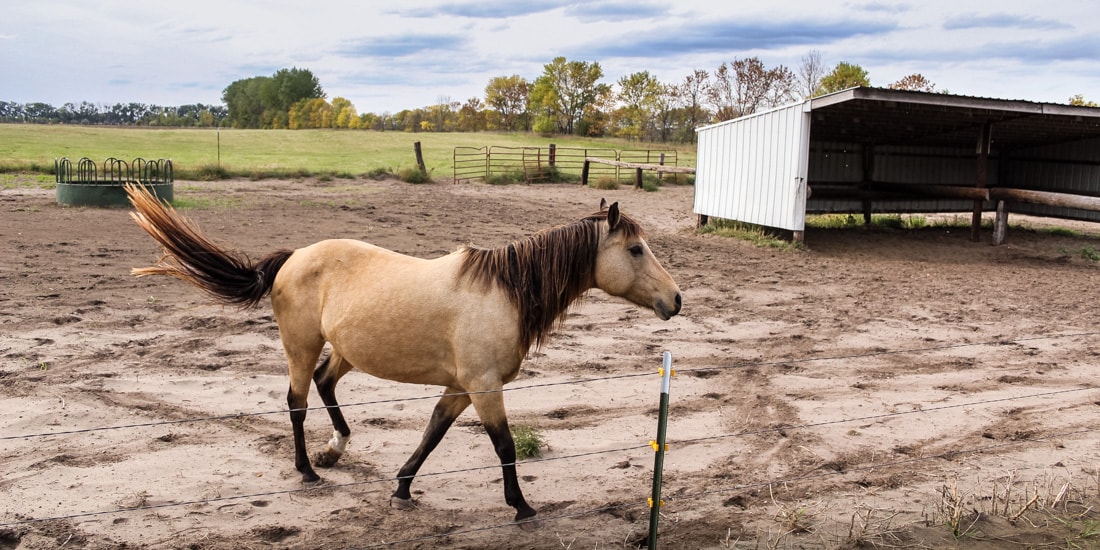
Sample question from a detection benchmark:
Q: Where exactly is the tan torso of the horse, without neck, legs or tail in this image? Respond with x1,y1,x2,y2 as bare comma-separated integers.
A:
272,240,521,385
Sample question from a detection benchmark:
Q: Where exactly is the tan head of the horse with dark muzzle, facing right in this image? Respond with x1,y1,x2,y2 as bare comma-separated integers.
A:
596,201,681,320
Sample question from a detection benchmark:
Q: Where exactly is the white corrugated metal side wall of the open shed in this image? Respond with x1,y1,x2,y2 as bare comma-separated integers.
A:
694,102,810,231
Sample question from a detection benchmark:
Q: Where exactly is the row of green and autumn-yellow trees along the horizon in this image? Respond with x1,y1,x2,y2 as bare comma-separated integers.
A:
0,51,1096,143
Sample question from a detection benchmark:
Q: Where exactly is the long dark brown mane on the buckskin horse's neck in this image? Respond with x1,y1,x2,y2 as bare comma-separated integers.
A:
459,210,642,351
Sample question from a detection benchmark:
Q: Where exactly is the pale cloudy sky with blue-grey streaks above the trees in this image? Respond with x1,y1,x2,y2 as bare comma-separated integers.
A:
0,0,1100,114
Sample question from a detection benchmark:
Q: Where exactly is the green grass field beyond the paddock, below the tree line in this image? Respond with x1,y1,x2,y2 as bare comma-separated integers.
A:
0,124,695,179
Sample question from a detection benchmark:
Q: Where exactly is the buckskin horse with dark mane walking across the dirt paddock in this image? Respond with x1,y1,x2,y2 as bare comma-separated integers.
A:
125,184,682,523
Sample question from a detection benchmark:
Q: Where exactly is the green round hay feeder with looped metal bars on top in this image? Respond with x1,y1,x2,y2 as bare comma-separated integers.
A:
54,157,174,208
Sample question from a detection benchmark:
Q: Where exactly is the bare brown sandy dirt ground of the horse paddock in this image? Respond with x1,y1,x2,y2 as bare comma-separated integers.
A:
0,179,1100,549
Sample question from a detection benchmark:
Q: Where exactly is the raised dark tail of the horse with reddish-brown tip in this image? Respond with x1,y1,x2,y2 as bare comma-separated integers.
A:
127,184,293,308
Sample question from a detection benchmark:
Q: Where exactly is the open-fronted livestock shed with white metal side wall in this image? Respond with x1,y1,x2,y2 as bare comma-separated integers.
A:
694,87,1100,243
